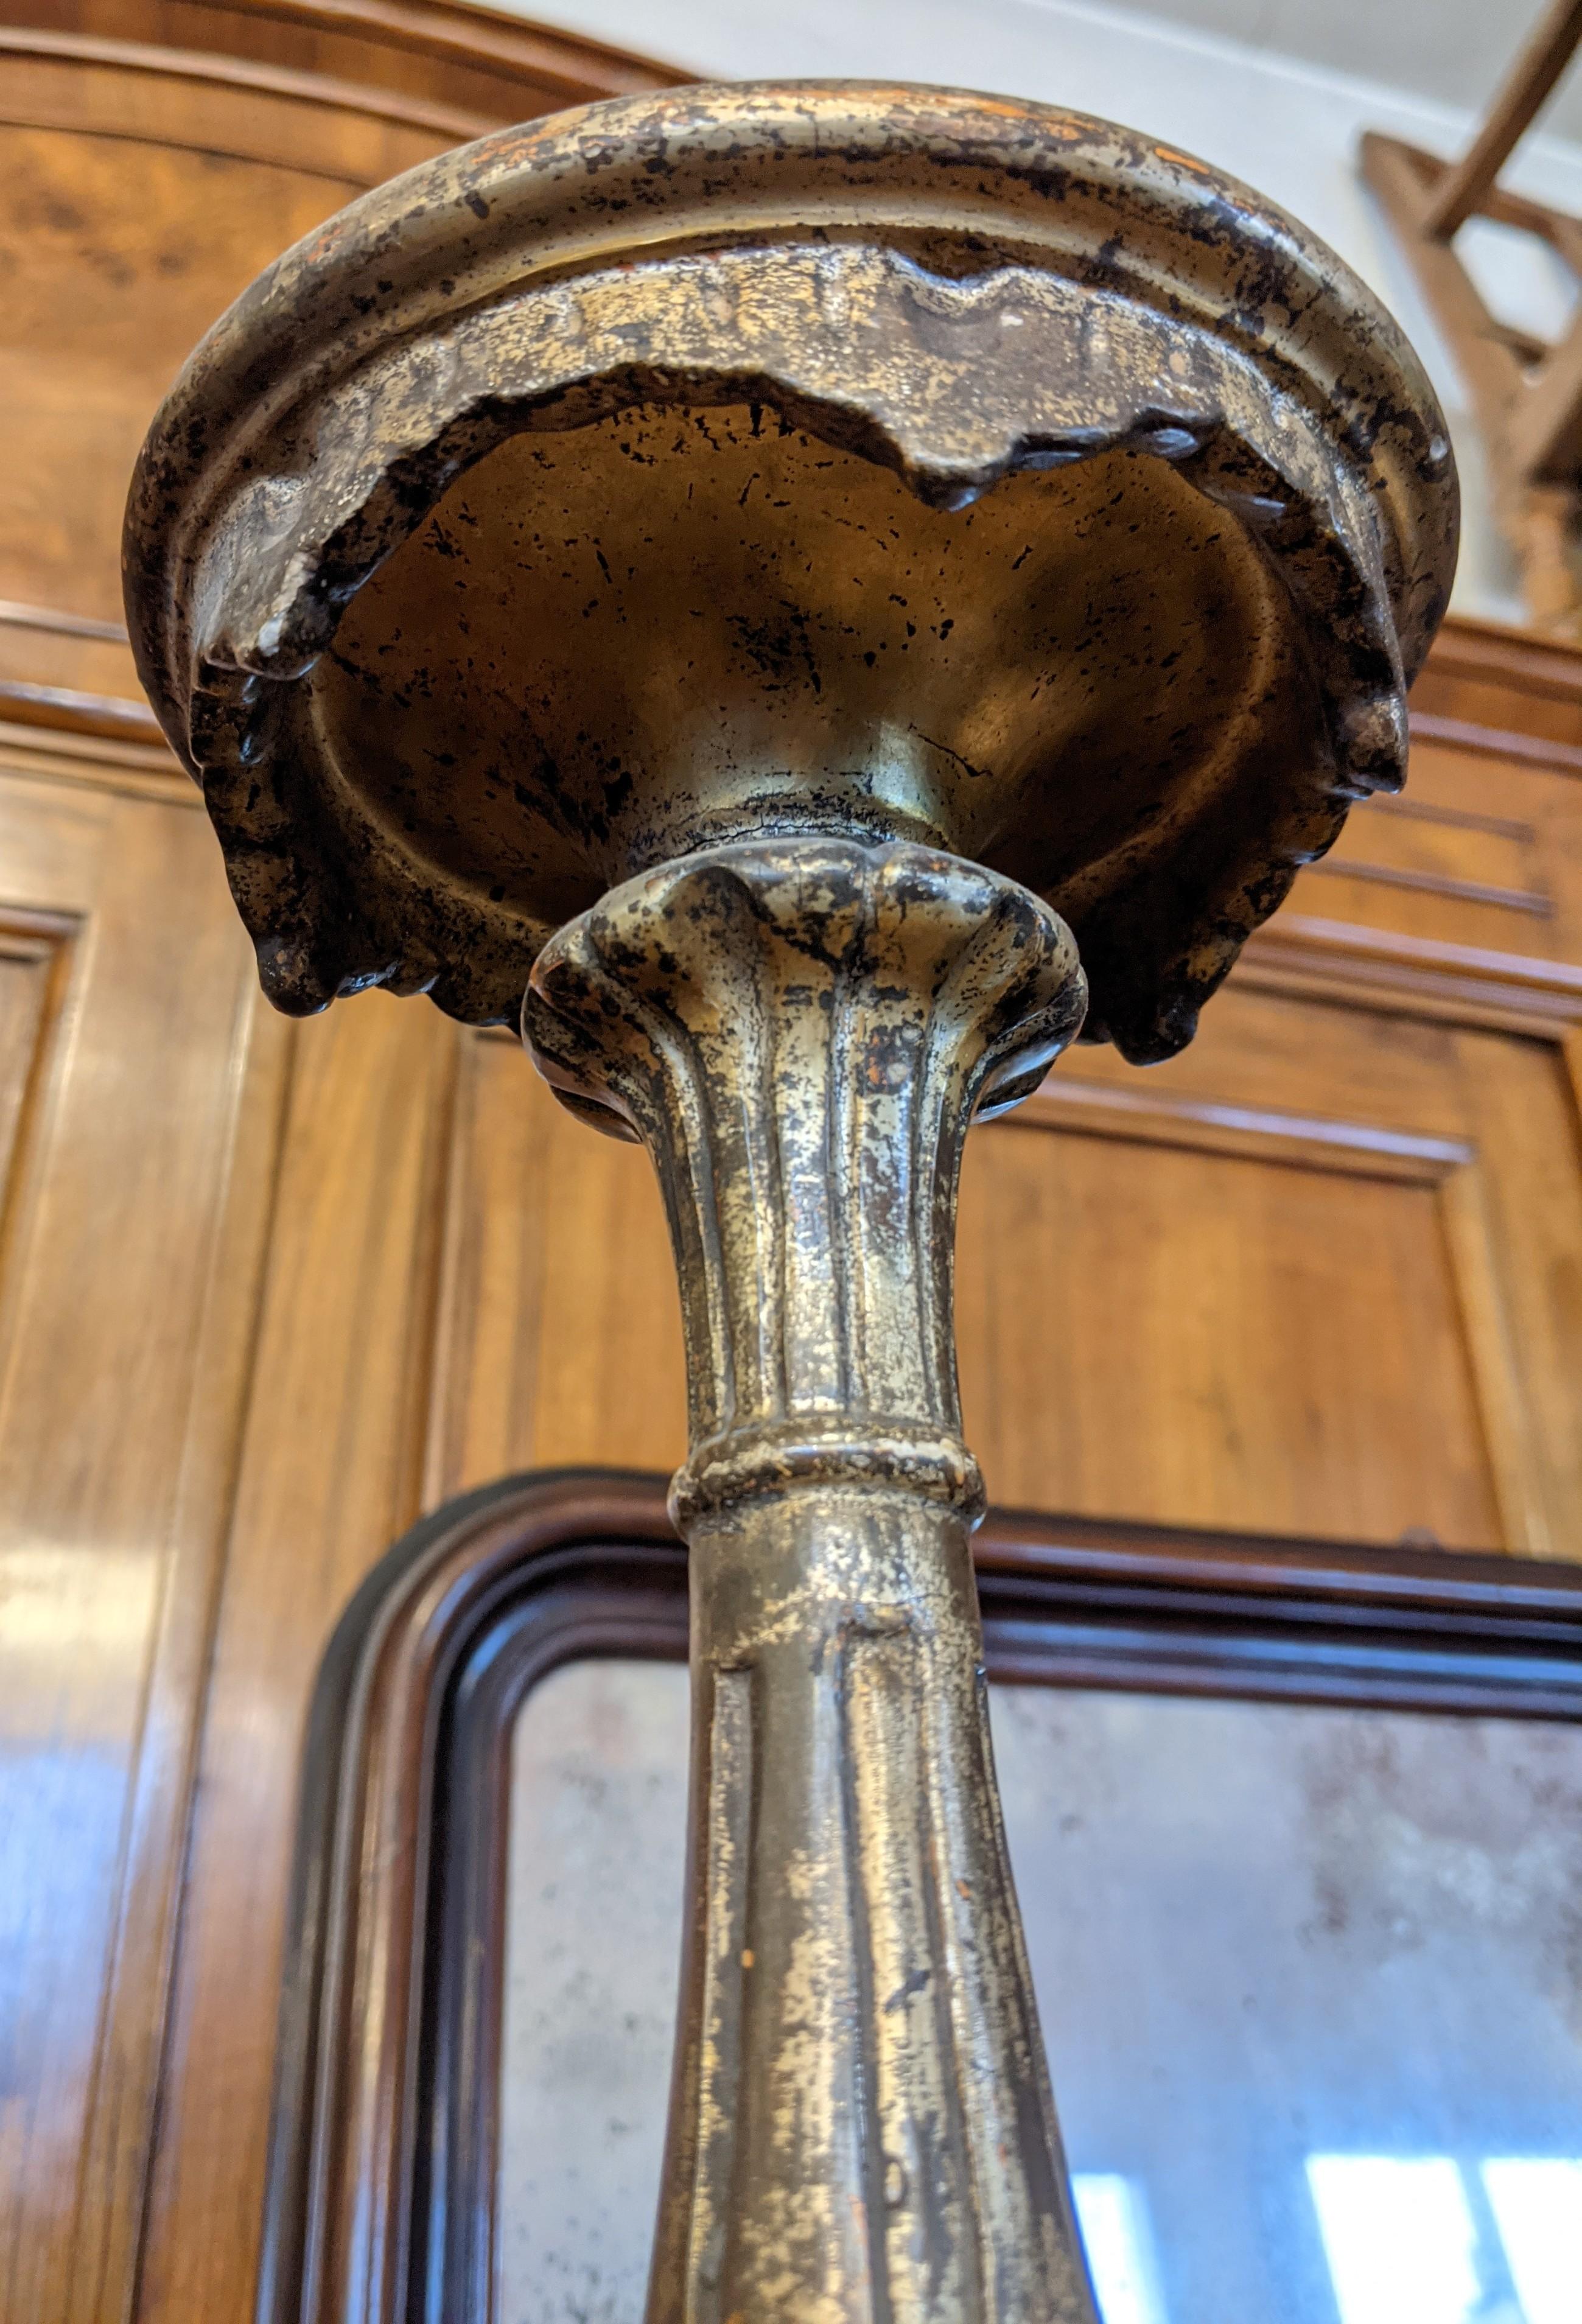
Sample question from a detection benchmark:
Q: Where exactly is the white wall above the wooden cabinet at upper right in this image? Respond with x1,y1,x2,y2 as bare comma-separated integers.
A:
525,0,1582,620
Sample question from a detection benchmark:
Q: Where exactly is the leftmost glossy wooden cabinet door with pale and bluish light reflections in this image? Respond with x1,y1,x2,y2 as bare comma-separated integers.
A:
0,746,284,2319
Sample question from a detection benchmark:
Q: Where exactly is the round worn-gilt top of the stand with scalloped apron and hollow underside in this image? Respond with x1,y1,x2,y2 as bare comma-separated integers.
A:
128,83,1457,1060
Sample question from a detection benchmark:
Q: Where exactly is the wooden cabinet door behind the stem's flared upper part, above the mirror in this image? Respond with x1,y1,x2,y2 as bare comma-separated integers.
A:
425,969,1582,1555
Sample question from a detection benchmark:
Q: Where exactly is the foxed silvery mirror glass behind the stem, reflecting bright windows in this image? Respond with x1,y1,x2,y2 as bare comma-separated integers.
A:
495,1659,1582,2324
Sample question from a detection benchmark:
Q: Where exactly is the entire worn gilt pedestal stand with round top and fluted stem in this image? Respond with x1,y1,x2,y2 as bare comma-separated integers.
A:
128,83,1457,2324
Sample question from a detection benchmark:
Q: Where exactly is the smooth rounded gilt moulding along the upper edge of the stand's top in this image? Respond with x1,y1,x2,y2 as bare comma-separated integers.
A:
125,82,1457,706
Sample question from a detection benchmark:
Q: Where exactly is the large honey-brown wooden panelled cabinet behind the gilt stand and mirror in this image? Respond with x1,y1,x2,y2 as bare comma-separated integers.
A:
0,0,1582,2324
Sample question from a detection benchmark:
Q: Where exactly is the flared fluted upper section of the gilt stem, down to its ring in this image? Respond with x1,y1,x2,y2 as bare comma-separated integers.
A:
523,836,1085,1522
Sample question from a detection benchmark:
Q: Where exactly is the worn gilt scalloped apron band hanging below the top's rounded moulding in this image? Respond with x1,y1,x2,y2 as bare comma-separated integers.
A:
188,244,1401,725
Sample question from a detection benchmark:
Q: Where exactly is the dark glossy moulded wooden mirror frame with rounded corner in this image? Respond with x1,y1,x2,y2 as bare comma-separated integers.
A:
258,1469,1582,2324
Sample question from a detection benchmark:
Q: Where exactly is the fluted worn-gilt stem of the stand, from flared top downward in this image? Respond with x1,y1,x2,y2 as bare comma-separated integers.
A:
525,839,1094,2324
